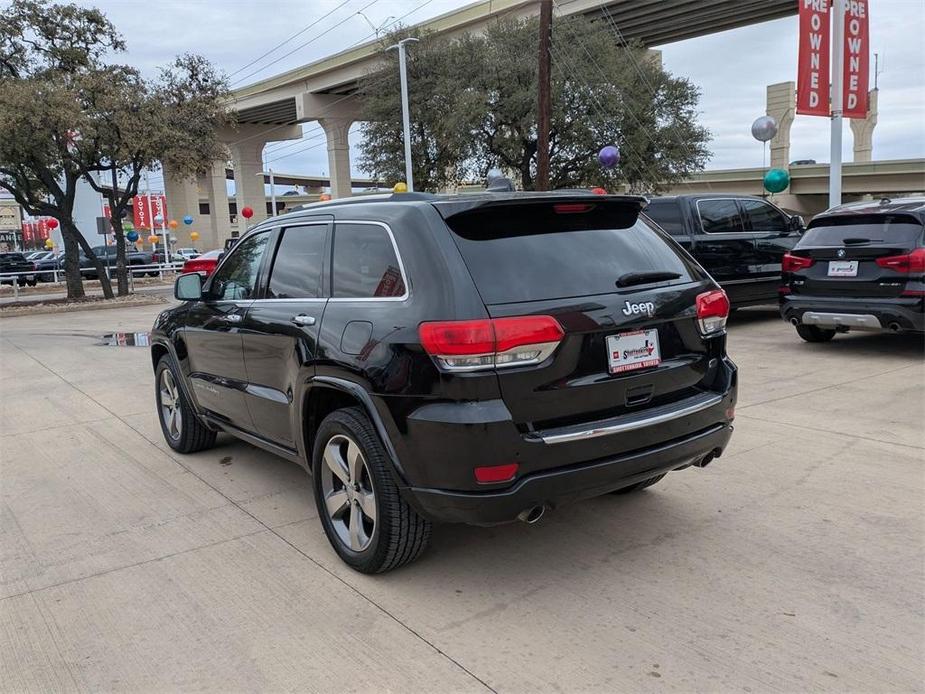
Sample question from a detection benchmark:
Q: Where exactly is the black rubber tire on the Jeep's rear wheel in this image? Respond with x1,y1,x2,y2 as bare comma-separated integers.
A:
312,407,431,574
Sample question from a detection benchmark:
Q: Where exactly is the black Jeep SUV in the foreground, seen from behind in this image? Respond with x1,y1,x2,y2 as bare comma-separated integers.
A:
152,193,736,573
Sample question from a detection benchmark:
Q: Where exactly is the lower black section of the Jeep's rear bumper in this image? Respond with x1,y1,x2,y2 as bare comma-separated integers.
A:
406,423,732,525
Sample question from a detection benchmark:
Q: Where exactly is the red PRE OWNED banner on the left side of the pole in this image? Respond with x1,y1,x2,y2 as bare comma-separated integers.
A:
797,0,831,116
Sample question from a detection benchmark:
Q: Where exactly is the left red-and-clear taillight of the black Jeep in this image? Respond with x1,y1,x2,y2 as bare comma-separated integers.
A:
418,316,565,371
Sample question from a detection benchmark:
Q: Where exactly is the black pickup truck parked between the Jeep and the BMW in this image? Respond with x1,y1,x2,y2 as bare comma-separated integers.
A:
645,194,803,308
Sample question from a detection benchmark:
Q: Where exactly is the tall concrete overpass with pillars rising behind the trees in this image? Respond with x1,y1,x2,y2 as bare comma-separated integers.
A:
164,0,797,250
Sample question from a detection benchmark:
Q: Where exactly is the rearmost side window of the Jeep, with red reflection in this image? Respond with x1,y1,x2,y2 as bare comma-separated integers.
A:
333,224,405,299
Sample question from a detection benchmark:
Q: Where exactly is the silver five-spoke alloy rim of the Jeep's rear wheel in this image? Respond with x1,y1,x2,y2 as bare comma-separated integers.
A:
321,434,376,552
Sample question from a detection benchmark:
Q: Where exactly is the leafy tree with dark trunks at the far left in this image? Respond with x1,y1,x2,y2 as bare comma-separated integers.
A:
0,0,229,299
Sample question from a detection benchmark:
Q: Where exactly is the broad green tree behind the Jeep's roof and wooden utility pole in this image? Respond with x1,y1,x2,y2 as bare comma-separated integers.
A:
360,17,709,191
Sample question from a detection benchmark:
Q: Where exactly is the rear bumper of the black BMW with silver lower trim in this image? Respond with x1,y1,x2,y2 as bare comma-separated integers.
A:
780,295,925,332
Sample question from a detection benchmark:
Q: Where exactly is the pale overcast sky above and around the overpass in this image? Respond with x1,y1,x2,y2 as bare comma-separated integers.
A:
68,0,925,190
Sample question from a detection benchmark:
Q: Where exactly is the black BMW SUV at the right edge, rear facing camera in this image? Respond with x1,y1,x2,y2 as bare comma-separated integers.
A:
780,198,925,342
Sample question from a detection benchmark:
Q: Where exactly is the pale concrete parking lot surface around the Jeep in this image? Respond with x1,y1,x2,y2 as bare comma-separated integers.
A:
0,307,925,692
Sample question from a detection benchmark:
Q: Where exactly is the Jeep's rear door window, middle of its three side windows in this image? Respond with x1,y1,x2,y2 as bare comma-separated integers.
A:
267,224,327,299
